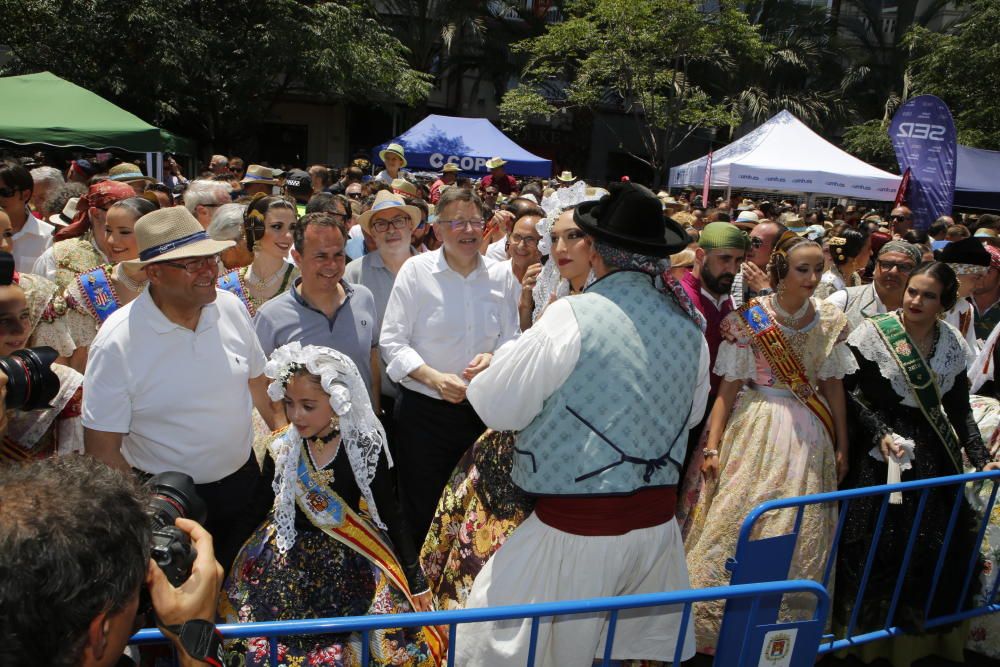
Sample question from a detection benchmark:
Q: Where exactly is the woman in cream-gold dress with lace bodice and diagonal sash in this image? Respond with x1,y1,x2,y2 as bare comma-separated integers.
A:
685,232,857,653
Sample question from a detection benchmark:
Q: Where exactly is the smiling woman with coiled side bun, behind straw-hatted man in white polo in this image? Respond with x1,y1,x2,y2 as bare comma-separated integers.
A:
218,194,299,317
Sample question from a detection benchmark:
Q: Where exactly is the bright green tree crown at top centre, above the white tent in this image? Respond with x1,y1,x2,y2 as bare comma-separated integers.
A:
500,0,765,179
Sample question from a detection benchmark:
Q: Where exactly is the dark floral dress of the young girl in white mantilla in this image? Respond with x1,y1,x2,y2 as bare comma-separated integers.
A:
220,436,438,667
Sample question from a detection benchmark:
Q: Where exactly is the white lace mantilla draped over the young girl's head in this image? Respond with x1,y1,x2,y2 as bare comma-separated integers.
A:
264,342,392,553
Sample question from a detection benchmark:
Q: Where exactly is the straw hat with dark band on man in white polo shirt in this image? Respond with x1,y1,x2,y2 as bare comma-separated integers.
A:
123,206,236,268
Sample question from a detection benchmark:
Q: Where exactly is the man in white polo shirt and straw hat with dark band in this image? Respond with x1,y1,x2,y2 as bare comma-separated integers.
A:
83,206,274,568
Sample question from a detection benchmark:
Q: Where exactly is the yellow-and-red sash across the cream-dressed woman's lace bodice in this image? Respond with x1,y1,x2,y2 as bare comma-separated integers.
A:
739,299,837,443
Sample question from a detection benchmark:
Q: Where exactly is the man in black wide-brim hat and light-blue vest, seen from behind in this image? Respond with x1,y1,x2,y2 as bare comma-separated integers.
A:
456,183,709,666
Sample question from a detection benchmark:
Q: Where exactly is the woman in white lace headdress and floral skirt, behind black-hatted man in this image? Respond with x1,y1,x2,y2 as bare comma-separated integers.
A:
420,181,593,609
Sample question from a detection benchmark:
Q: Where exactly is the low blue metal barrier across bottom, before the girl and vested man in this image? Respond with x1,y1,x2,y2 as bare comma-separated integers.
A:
131,581,830,667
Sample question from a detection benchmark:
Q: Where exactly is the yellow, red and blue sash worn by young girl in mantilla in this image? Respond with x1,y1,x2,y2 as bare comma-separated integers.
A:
279,438,447,664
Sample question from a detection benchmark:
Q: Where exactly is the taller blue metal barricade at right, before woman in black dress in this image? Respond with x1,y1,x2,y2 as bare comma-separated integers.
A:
716,470,1000,664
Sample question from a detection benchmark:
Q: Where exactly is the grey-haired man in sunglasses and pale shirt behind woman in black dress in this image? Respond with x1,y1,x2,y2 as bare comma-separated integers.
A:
827,241,921,329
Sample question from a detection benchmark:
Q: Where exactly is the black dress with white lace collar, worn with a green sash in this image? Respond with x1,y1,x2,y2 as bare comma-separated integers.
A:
833,320,990,667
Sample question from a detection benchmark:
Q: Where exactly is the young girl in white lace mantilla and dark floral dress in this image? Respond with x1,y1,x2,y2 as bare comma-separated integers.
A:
220,343,443,667
